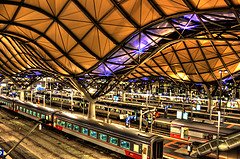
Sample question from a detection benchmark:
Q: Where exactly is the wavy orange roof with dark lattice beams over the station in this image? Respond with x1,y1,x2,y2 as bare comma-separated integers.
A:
0,0,240,98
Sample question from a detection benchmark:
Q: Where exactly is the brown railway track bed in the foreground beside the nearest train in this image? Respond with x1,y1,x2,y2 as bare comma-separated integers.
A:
0,111,120,159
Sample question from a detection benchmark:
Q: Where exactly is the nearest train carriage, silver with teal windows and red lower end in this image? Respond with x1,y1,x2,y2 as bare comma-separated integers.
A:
54,112,163,159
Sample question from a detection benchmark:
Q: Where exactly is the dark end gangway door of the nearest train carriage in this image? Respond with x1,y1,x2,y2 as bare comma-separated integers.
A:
152,140,163,159
